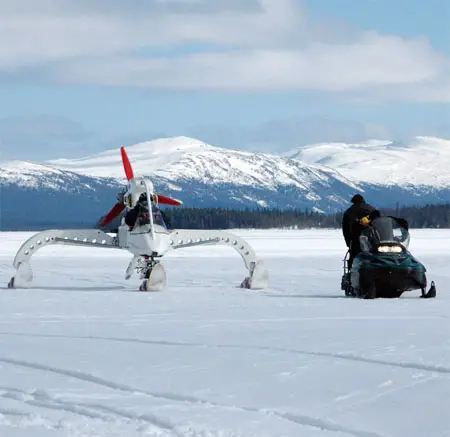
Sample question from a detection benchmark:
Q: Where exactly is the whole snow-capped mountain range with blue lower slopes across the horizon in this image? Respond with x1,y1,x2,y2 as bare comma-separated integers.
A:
0,133,450,227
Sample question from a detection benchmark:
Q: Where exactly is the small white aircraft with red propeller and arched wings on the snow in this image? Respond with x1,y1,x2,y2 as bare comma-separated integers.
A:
8,147,268,291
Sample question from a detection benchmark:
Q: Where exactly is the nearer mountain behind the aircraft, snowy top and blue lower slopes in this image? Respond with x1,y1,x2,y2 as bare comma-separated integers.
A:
0,137,359,228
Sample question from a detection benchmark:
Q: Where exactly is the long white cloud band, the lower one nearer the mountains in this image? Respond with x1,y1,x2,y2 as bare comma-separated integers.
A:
51,34,445,91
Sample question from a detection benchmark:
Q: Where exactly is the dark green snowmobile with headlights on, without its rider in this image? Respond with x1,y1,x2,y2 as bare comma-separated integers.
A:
341,216,436,299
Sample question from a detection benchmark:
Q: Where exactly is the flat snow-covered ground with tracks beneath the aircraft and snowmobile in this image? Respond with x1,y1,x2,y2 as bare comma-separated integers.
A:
0,230,450,437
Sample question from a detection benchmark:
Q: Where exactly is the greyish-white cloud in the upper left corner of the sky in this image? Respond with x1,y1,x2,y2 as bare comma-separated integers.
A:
0,0,300,68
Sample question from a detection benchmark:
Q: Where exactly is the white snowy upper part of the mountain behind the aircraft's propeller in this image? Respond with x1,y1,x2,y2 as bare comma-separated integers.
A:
49,137,356,190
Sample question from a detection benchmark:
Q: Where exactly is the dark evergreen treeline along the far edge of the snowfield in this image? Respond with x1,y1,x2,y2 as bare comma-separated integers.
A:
164,204,450,229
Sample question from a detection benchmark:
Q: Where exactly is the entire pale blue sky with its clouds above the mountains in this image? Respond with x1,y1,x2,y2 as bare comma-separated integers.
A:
0,0,450,160
